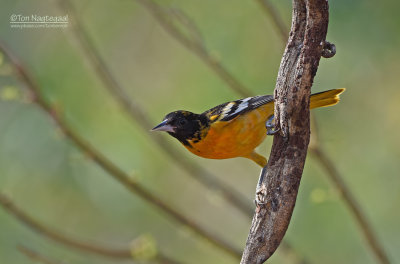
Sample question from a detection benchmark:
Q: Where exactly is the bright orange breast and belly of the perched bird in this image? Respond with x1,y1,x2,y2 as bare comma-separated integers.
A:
186,103,274,159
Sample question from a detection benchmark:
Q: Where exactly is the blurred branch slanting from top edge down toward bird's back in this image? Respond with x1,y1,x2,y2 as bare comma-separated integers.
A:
136,0,251,97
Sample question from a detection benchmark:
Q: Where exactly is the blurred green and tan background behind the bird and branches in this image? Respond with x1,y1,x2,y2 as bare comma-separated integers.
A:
0,0,400,264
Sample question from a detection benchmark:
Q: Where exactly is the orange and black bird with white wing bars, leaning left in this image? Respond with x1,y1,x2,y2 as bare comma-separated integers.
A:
152,88,345,167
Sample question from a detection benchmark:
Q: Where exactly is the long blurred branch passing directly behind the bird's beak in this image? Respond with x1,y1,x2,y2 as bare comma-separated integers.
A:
59,0,253,216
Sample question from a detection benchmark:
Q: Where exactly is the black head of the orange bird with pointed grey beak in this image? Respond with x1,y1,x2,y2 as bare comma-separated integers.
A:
152,110,207,145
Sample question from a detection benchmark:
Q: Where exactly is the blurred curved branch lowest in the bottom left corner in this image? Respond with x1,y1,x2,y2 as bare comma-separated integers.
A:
0,193,177,263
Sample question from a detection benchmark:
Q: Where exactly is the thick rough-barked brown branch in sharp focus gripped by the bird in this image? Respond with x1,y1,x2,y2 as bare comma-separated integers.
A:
241,0,329,263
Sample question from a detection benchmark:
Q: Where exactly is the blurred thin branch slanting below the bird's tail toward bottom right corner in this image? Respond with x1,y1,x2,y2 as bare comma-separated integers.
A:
310,146,390,264
